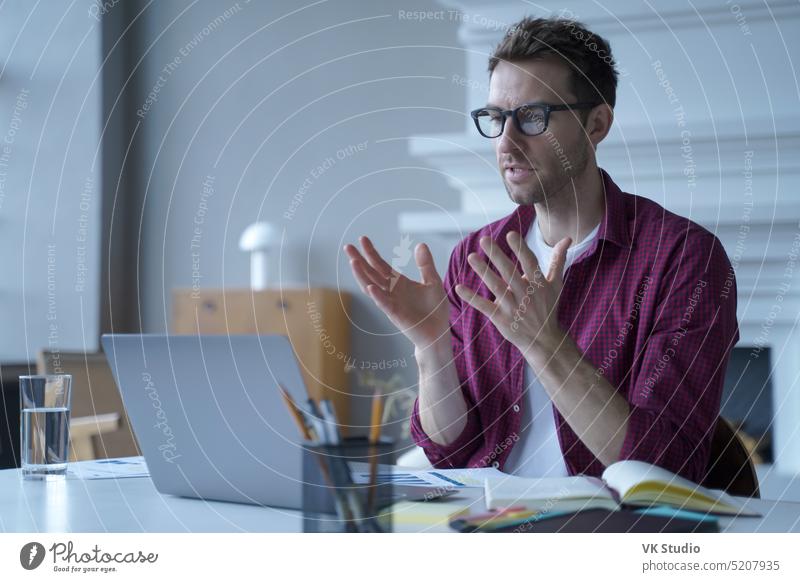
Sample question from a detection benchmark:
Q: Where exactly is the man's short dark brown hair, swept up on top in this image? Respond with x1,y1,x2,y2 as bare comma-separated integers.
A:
489,17,617,109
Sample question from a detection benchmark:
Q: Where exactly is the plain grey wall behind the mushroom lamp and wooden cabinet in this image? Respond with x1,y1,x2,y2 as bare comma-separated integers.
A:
128,0,465,438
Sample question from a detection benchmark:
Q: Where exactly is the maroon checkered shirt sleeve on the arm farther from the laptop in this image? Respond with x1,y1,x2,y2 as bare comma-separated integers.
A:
620,231,739,483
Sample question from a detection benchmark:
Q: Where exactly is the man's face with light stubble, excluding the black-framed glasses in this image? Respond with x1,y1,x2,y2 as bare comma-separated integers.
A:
488,58,593,205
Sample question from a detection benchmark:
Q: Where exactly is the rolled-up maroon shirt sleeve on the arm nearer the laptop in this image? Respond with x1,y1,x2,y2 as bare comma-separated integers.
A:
411,241,483,468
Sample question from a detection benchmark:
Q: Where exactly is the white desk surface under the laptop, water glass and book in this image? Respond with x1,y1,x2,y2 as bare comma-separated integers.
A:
0,469,800,533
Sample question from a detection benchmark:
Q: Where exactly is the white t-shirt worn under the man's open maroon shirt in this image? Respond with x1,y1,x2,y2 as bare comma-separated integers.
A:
503,219,600,477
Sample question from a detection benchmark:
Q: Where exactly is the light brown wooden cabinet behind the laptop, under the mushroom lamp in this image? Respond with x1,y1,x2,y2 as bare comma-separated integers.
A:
172,288,352,432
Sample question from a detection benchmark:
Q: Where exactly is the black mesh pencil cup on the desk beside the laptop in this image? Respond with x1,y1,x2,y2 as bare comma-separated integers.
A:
303,437,395,533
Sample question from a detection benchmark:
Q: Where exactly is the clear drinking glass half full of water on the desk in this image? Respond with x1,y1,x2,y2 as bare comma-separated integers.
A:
19,374,72,479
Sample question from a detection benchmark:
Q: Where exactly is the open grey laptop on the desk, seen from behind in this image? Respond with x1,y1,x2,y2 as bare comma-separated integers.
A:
102,334,307,509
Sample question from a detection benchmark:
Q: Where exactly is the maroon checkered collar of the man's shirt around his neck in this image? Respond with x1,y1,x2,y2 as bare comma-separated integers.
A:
495,168,631,251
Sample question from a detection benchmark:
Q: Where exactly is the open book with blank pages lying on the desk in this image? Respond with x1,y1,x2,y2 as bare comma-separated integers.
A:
484,461,759,516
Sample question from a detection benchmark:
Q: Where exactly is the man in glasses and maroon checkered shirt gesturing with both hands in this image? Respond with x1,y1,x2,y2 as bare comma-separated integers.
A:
345,18,739,481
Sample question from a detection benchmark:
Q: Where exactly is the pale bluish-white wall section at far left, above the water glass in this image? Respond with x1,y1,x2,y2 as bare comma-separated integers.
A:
0,0,101,362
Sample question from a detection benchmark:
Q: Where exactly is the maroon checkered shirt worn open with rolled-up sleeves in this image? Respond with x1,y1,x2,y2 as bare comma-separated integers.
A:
411,170,739,482
